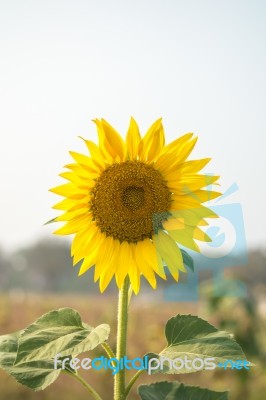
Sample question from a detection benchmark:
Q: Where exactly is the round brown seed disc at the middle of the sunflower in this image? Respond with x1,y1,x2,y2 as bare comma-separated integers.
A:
91,161,171,243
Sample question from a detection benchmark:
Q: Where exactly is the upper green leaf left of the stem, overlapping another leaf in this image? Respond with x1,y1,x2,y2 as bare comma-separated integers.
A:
15,308,110,365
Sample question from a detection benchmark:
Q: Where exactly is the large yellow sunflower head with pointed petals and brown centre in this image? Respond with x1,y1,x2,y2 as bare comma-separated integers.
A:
51,118,220,293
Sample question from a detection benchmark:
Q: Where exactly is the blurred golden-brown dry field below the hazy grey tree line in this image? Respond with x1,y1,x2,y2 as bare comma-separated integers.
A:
0,291,266,400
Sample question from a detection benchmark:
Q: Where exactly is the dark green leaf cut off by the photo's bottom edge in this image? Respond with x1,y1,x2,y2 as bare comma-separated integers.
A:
138,381,229,400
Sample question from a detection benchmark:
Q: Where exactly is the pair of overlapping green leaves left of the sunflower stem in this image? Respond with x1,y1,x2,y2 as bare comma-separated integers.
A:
0,308,110,390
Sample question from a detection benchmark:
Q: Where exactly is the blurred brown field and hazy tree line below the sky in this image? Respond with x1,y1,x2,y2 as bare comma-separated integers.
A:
0,239,266,400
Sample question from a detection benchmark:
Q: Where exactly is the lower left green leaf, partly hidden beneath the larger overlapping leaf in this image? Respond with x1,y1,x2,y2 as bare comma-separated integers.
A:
0,331,60,390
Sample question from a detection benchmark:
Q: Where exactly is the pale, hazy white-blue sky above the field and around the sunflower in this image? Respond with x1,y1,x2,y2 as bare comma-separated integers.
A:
0,0,266,249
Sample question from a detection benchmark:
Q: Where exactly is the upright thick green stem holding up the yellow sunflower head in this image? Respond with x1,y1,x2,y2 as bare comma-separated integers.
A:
114,277,129,400
